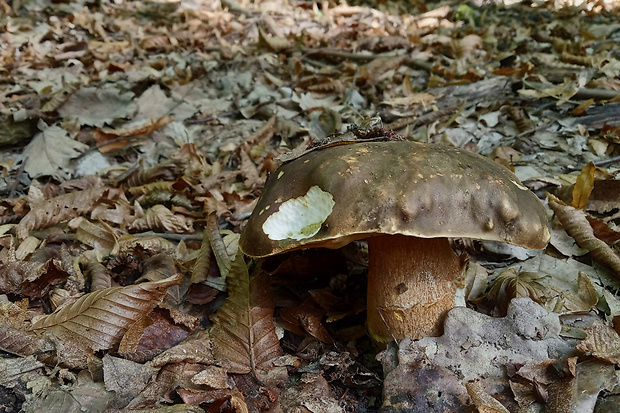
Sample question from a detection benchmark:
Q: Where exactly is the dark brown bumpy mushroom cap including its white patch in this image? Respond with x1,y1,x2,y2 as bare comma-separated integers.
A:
240,142,549,257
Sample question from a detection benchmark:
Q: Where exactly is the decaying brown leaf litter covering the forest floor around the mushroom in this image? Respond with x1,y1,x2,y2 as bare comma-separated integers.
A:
0,0,620,412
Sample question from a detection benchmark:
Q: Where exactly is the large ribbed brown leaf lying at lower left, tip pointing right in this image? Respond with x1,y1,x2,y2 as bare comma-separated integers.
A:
31,275,183,351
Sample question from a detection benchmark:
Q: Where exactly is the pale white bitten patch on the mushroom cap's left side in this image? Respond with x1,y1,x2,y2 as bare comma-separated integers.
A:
263,186,336,241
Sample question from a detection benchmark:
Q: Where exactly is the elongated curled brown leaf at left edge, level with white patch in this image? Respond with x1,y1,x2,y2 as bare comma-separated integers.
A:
17,186,120,239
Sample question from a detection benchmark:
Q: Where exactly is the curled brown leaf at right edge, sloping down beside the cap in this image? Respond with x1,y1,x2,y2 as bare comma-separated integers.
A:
549,194,620,278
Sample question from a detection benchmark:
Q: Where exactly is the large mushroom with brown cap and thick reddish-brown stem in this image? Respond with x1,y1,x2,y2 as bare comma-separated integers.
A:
239,141,549,344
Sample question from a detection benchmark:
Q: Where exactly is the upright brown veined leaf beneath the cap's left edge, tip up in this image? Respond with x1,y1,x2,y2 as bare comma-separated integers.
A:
210,253,282,377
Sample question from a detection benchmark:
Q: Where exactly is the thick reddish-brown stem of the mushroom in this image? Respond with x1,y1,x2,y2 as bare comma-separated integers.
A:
367,235,467,344
